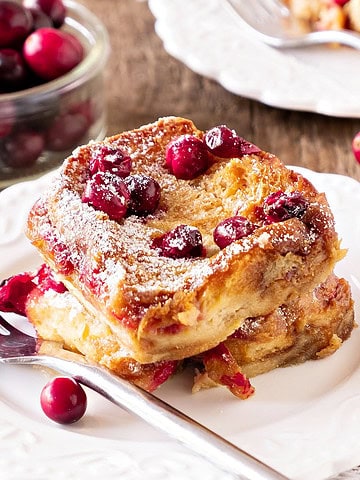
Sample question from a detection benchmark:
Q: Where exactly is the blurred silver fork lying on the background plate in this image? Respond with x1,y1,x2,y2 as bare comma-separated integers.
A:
224,0,360,49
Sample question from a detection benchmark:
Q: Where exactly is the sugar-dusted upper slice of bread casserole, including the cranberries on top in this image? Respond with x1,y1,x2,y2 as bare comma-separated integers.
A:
27,117,343,363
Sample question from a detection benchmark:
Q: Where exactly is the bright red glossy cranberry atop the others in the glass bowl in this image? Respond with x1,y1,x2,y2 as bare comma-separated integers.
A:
23,28,84,80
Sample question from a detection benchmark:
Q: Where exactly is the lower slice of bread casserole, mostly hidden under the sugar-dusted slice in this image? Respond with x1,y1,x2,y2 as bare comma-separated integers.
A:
26,266,354,398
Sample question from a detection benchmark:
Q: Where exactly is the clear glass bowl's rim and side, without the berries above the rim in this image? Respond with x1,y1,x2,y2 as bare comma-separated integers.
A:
0,0,110,189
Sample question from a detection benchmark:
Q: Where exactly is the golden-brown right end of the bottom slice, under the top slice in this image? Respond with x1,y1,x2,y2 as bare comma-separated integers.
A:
225,275,354,377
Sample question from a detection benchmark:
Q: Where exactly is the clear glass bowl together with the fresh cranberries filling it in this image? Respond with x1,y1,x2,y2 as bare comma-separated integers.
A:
0,0,109,189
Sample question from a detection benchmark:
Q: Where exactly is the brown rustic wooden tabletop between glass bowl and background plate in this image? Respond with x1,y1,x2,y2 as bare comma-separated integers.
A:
81,0,360,180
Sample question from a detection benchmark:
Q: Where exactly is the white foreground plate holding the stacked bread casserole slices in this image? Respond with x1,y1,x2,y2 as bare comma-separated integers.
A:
0,169,360,480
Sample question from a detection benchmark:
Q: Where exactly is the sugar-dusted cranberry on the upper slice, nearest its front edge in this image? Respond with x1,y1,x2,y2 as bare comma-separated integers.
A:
152,225,203,258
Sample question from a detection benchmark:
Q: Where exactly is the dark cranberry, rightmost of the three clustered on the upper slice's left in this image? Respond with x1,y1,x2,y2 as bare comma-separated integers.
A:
124,174,160,215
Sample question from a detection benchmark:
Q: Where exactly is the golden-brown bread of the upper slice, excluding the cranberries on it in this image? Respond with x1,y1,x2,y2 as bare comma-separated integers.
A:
27,117,343,363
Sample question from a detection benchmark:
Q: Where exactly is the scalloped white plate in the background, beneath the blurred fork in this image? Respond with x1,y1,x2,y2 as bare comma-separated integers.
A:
149,0,360,118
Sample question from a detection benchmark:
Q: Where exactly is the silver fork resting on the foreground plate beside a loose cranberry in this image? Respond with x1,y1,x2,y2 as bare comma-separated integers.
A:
0,316,288,480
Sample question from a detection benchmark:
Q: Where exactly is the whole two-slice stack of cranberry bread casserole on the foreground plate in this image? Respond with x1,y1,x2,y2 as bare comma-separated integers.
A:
0,117,354,398
